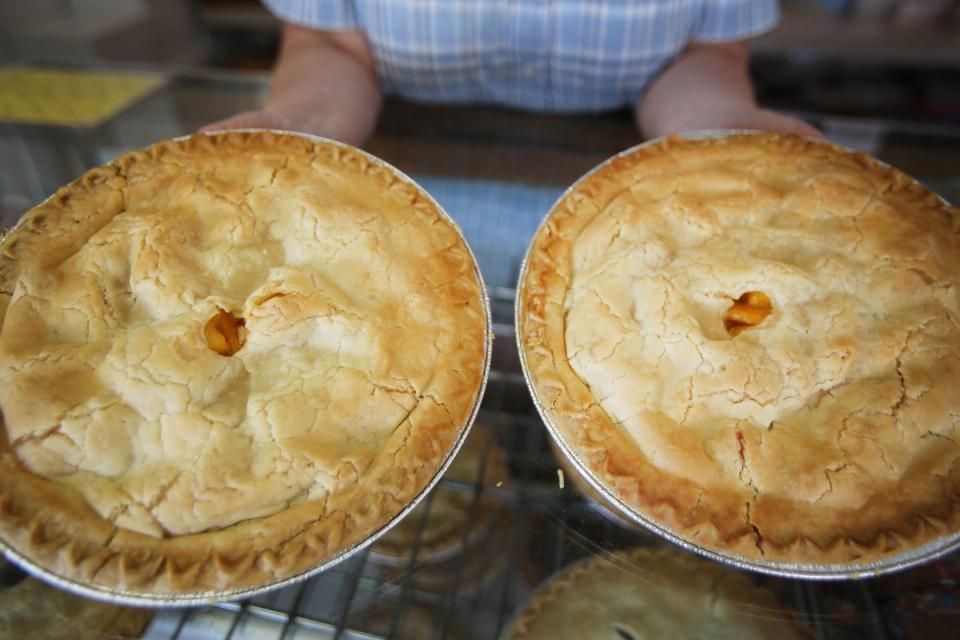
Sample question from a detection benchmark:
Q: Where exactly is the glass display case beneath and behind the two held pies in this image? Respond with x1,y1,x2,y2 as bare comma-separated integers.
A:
0,68,960,639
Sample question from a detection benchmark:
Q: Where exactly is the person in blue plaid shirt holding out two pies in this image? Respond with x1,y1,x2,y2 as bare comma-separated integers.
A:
202,0,821,145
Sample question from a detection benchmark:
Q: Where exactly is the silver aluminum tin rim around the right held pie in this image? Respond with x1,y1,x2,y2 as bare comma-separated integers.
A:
514,129,960,581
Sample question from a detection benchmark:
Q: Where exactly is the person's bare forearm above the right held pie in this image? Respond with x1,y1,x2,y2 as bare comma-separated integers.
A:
637,43,756,138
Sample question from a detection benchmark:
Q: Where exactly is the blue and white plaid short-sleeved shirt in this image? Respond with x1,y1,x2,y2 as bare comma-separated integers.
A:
264,0,778,112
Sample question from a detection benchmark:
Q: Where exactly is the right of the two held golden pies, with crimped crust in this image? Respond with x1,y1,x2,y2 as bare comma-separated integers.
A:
517,133,960,570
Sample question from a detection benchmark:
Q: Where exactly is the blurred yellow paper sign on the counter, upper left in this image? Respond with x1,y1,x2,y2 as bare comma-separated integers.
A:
0,67,165,127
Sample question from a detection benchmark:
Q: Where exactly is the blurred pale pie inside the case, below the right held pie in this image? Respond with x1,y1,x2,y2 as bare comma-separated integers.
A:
504,547,815,640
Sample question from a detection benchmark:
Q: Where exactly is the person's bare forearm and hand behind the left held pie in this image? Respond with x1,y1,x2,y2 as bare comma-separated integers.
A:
200,24,382,145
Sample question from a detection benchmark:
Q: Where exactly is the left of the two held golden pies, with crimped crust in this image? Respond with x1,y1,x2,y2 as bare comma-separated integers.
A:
0,131,489,598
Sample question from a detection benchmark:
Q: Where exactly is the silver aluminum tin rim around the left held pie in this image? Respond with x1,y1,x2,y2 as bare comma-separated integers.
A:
0,128,493,608
